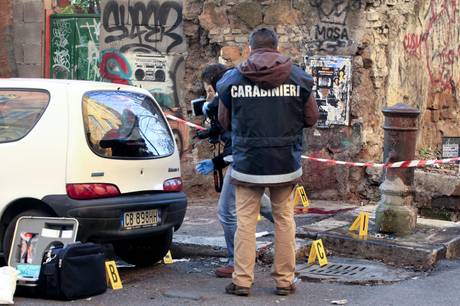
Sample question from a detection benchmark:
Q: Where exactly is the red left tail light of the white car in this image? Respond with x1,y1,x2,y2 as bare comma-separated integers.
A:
66,184,120,200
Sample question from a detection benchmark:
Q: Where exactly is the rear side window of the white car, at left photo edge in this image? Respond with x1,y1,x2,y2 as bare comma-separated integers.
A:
0,89,49,143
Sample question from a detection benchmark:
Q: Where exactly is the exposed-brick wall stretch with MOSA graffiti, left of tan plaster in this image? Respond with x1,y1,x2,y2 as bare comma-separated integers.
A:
184,0,388,198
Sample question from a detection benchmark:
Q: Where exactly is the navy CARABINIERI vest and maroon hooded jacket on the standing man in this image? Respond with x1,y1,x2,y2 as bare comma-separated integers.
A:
217,29,319,185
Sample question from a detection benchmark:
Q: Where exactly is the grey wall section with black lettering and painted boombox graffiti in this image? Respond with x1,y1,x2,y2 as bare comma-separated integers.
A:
99,0,189,150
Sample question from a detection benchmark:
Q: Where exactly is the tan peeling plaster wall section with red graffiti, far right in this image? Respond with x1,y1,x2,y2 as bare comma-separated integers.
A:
389,0,460,149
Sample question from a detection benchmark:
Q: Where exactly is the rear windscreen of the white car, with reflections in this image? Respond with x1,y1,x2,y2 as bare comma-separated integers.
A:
83,91,174,159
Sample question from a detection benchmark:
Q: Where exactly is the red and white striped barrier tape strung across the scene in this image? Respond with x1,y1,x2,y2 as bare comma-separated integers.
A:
165,114,460,168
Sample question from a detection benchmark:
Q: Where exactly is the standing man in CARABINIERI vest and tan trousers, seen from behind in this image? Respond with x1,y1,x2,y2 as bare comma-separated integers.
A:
217,28,319,295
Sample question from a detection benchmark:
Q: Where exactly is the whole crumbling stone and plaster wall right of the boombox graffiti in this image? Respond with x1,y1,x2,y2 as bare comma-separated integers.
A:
184,0,460,199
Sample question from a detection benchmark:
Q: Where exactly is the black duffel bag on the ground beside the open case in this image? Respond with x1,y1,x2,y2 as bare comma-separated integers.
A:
38,243,107,300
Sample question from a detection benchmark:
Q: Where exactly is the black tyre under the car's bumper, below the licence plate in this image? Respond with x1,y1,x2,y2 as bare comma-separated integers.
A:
113,228,173,267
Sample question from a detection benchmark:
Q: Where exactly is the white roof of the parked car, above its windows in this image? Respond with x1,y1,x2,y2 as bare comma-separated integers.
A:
0,78,145,92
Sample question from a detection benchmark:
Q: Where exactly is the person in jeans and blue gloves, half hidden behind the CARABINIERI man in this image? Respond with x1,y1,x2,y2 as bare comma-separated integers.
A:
195,63,273,278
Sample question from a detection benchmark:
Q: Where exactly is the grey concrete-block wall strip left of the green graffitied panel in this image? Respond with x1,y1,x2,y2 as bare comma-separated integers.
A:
13,0,45,78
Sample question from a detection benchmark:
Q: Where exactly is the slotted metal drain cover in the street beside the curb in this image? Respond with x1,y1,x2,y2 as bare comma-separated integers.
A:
297,257,417,285
